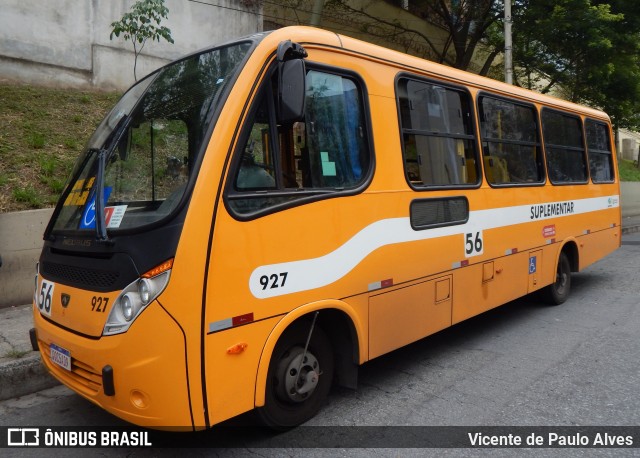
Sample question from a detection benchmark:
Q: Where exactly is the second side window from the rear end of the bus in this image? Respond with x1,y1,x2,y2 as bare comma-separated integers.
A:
542,109,587,184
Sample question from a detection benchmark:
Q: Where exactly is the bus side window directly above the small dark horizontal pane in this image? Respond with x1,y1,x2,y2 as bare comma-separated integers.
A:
397,78,478,188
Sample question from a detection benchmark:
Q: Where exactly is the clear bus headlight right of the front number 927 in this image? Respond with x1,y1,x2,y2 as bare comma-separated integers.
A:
102,269,171,336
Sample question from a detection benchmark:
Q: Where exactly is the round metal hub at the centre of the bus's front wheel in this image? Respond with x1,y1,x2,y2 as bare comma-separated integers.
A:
276,347,320,402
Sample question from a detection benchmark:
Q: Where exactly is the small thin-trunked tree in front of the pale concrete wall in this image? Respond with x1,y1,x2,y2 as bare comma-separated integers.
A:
109,0,174,81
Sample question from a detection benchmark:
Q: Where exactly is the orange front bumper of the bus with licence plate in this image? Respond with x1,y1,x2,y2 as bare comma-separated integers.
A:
33,302,194,430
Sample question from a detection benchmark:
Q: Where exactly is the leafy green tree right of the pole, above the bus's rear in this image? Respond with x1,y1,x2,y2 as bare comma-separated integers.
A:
513,0,640,127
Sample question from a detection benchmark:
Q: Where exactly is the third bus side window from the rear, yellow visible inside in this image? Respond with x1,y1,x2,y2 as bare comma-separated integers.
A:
479,96,544,184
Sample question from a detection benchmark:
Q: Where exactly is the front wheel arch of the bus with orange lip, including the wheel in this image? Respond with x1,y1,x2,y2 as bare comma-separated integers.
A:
255,306,359,430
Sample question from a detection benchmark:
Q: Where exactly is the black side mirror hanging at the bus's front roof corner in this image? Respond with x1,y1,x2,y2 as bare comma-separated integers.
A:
277,40,307,124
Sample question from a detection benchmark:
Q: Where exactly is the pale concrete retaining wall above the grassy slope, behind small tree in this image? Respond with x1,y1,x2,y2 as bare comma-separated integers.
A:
0,0,262,90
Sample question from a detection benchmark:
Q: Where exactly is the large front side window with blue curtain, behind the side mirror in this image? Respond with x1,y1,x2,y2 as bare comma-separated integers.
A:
226,69,371,214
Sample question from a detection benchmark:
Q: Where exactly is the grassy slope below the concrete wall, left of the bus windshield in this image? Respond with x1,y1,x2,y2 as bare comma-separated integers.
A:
0,83,120,213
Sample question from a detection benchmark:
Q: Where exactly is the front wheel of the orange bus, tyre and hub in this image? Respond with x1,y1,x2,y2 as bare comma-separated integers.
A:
257,321,333,430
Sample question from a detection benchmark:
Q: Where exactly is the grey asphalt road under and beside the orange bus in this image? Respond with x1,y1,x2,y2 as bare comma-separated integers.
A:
0,233,640,456
